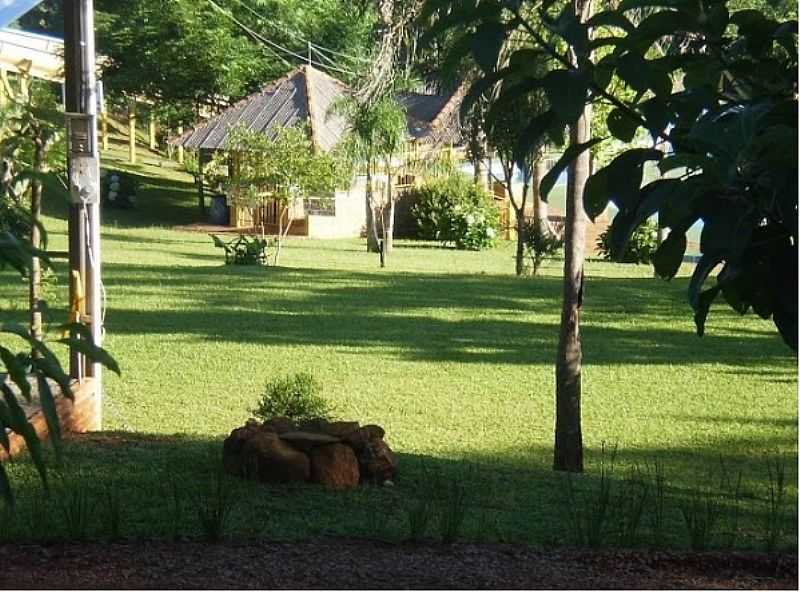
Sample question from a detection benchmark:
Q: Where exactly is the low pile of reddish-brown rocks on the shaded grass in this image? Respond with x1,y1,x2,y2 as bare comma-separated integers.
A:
223,417,397,489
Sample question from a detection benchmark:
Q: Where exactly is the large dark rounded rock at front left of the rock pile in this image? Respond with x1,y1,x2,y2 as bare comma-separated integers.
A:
238,431,311,483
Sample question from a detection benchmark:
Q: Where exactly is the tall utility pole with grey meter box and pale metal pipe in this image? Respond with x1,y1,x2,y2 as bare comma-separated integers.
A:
63,0,103,429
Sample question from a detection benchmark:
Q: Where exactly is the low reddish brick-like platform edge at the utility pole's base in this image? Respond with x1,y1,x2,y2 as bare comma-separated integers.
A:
0,378,101,462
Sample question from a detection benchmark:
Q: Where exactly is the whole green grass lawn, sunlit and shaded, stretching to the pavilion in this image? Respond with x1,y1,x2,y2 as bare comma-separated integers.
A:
0,155,797,549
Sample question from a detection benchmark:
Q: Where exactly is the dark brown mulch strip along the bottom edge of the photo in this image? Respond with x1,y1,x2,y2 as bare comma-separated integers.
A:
0,539,798,590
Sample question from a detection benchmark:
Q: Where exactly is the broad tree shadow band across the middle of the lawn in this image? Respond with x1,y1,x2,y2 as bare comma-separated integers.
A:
94,265,790,368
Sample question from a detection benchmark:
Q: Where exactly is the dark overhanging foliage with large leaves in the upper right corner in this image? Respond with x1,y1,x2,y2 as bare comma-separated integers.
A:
423,0,798,350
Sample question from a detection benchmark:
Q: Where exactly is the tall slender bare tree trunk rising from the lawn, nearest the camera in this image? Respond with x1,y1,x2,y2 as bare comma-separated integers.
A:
553,105,592,472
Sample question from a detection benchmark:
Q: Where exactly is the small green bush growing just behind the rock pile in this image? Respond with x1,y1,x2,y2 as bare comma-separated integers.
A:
252,372,331,421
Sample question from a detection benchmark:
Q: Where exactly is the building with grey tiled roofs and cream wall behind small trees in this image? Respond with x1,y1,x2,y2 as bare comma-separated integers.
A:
170,65,463,238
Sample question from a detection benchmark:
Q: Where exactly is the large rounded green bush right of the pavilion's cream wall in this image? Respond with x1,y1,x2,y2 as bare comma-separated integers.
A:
411,175,500,251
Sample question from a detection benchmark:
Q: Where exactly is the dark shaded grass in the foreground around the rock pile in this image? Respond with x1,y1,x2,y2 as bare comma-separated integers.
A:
4,432,797,549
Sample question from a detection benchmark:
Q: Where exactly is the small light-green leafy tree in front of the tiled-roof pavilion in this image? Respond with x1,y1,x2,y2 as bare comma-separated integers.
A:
227,127,343,265
